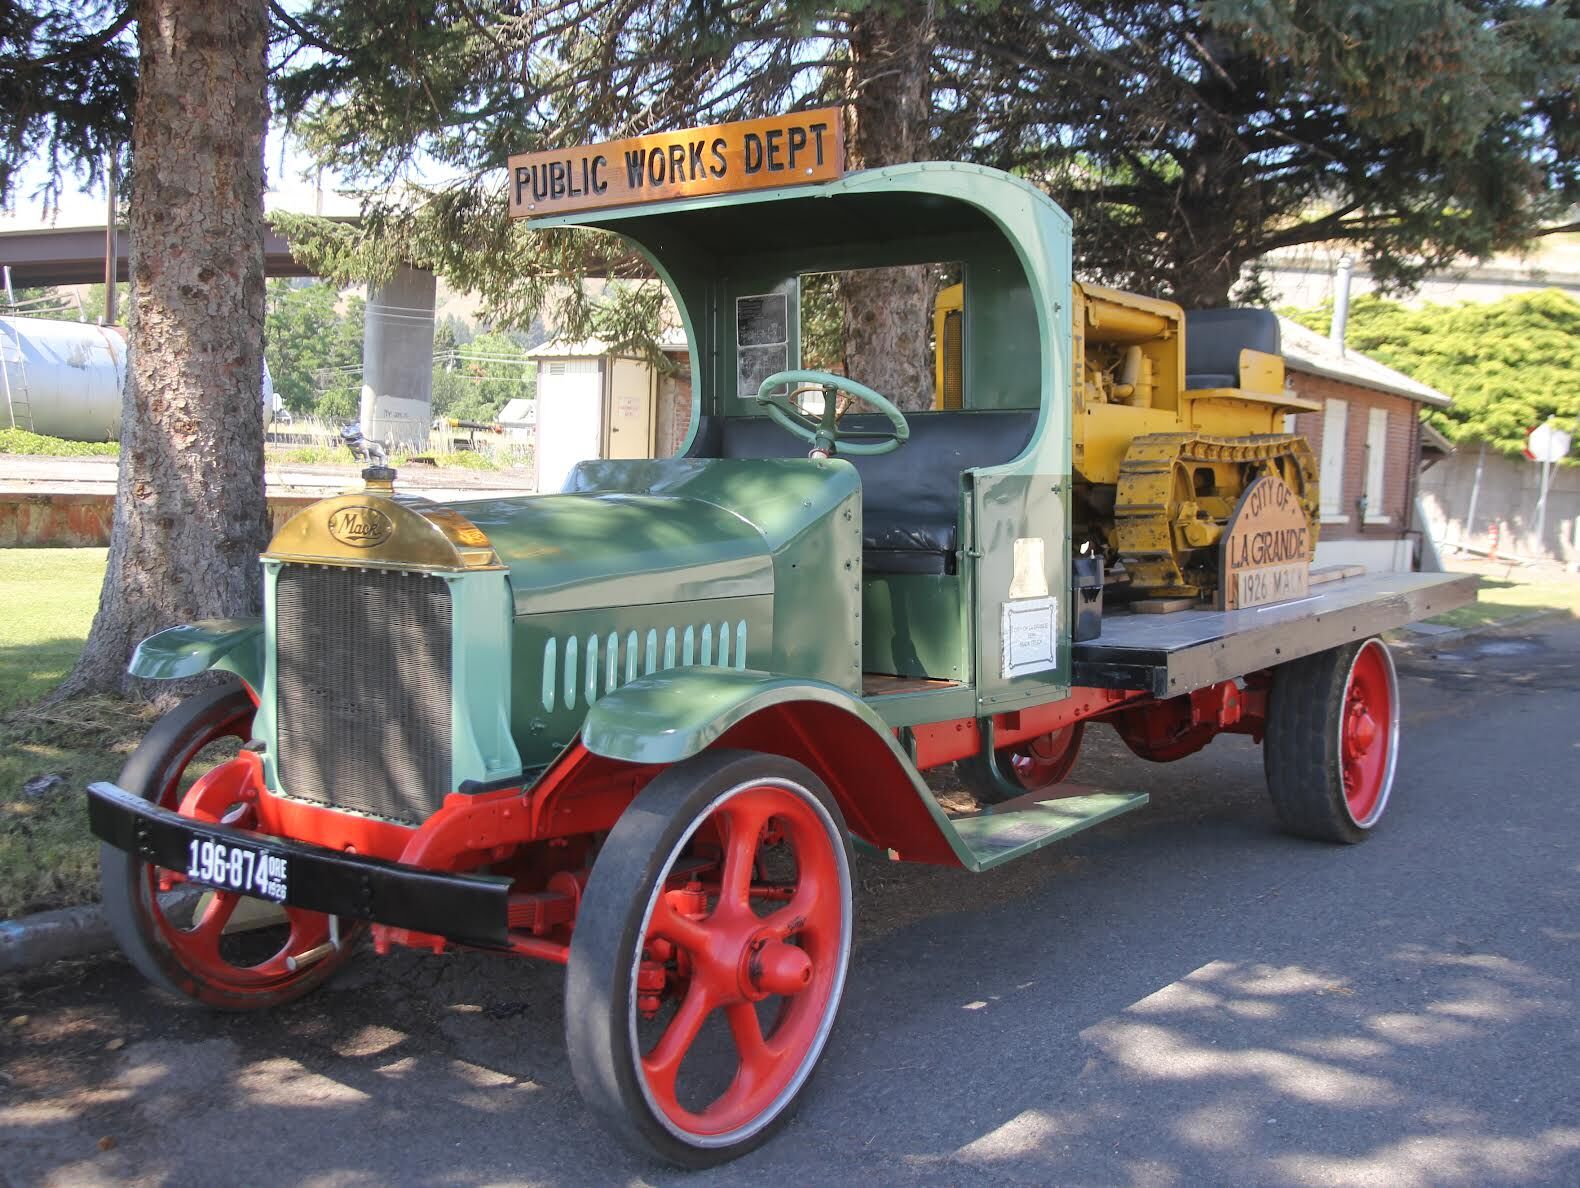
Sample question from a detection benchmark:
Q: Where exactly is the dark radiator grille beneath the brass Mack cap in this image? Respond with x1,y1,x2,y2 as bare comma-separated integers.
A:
275,564,450,823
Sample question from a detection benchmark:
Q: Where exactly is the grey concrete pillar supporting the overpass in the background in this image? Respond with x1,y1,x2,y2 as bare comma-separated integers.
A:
362,265,438,449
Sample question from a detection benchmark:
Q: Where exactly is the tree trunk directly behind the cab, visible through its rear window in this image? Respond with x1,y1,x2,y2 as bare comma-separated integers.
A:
841,3,935,409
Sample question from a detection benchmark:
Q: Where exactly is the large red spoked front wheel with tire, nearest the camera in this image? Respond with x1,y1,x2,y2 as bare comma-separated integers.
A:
566,750,852,1167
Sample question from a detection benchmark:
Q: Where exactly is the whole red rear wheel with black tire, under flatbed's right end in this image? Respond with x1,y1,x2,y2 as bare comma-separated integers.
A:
1262,638,1398,842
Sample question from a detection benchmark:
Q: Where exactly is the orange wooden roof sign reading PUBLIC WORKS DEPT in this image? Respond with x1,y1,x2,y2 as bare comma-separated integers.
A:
510,107,845,218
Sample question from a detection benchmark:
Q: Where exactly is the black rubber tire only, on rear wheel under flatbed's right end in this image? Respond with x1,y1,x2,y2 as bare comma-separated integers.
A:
1262,640,1398,845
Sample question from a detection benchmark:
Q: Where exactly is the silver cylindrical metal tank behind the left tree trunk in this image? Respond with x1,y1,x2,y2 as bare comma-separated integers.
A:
0,318,275,441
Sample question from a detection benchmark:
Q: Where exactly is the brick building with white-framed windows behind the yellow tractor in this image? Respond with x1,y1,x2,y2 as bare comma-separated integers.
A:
1278,318,1449,572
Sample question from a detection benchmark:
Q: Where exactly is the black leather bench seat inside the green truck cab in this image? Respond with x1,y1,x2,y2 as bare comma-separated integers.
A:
692,409,1036,573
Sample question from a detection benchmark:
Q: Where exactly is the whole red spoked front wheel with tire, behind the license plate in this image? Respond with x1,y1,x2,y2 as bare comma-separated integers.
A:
100,684,354,1011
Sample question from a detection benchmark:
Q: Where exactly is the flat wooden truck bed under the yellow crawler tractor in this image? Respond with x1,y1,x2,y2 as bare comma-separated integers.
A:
1071,573,1477,697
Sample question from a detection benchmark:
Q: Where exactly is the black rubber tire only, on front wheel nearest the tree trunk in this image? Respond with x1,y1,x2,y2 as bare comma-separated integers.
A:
100,681,351,1011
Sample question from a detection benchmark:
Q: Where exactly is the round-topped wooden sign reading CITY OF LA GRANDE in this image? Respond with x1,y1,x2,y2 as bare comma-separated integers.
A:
1218,474,1313,610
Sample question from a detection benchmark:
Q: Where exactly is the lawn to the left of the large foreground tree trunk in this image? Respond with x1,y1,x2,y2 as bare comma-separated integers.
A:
0,548,149,919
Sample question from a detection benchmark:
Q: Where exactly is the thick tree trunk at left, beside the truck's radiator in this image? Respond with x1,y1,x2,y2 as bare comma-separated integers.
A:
57,0,269,697
